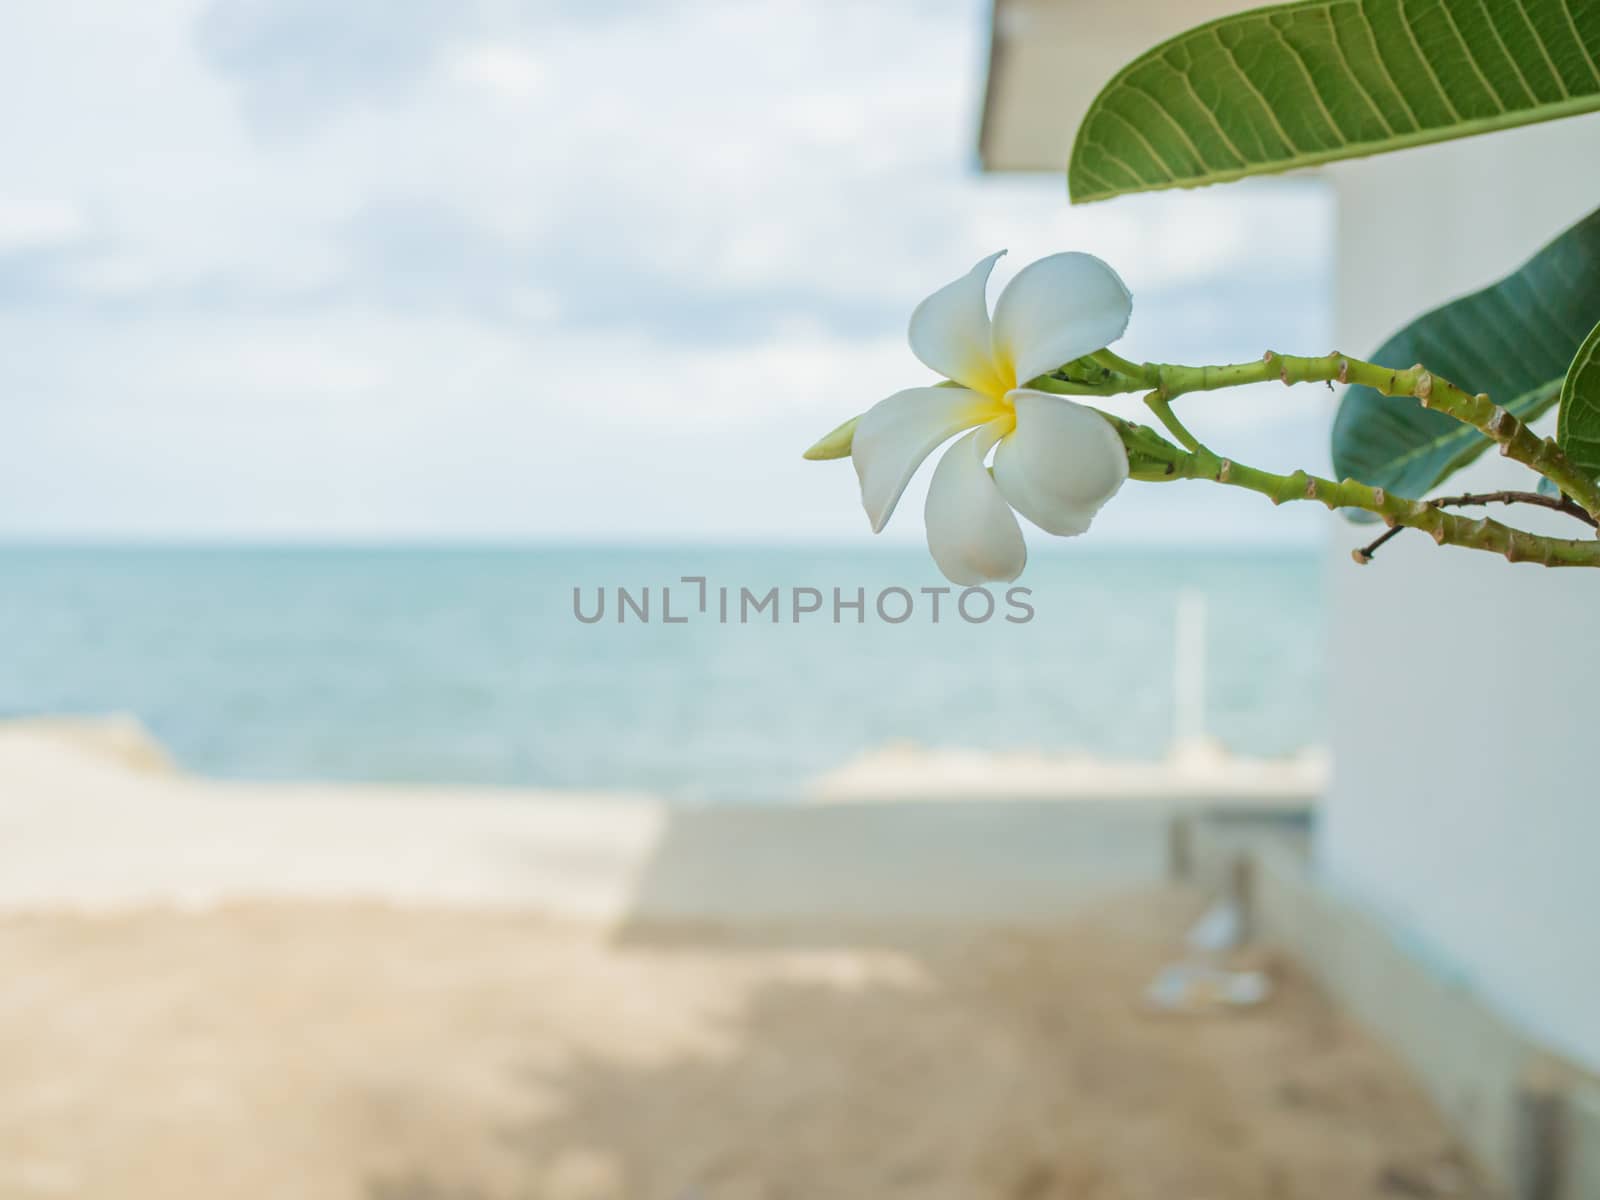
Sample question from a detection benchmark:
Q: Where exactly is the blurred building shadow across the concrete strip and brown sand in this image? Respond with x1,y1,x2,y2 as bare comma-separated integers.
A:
366,803,1475,1200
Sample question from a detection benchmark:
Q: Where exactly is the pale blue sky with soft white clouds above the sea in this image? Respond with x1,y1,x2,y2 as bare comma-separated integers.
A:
0,0,1330,541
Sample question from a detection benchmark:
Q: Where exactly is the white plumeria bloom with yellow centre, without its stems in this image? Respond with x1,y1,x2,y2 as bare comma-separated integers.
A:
850,250,1133,586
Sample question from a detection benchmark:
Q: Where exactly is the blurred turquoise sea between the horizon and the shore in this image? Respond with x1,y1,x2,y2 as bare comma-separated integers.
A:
0,546,1323,800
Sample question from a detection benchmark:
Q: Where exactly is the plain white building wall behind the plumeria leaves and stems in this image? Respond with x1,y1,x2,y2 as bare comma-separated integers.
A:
1318,117,1600,1070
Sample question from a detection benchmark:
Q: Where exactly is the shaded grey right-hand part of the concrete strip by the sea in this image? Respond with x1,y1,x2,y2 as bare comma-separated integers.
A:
629,800,1171,923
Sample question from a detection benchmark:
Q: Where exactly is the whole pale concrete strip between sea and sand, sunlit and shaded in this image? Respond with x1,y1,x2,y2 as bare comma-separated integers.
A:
0,723,1173,923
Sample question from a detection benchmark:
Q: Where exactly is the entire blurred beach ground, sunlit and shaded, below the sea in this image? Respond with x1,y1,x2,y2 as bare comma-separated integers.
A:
0,725,1486,1200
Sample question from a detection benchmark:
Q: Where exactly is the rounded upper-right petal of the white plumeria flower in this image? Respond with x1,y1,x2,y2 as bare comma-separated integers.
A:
992,253,1133,384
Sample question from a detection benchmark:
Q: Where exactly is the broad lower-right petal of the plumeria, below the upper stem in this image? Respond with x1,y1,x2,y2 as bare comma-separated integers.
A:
995,389,1128,538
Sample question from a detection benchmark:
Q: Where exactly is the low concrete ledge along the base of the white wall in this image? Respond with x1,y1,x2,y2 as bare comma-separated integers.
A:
1235,832,1600,1200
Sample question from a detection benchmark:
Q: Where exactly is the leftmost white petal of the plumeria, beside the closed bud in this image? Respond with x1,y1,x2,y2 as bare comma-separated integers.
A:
850,387,995,533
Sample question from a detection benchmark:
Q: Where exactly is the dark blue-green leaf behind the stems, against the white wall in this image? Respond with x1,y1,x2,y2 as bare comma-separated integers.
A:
1333,210,1600,496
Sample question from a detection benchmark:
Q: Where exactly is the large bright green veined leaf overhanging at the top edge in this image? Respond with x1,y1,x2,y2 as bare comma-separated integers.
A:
1067,0,1600,203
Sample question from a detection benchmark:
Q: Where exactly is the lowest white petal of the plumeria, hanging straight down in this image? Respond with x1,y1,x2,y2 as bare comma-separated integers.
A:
923,421,1027,587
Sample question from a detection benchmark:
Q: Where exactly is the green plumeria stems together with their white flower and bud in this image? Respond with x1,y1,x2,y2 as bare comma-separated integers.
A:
806,253,1600,586
